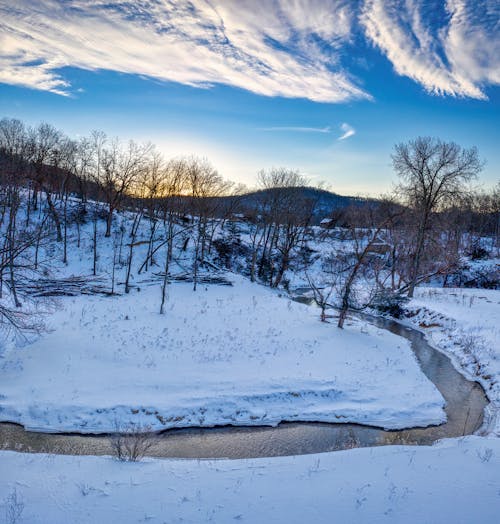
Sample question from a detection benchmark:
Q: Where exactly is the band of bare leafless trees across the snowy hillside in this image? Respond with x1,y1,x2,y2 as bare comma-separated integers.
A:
0,118,500,334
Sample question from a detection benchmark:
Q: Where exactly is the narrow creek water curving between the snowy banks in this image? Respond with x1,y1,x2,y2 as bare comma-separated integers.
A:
0,316,488,458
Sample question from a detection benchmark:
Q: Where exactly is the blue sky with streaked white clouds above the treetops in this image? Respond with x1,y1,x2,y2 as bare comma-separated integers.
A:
0,0,500,195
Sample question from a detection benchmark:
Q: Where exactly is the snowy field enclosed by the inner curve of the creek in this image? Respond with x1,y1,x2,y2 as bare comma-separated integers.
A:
0,275,445,432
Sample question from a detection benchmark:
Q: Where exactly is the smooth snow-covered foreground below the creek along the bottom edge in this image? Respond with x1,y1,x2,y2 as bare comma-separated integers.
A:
0,437,500,524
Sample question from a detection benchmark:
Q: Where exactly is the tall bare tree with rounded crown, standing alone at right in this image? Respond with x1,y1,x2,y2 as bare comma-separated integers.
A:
392,137,482,297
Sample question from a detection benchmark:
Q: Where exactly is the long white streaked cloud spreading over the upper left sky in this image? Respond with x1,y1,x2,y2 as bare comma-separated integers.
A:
0,0,369,102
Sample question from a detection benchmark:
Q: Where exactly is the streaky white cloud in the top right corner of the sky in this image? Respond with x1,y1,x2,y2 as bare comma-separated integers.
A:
361,0,500,99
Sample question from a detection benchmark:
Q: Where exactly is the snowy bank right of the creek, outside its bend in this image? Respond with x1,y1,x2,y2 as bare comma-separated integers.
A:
408,287,500,436
